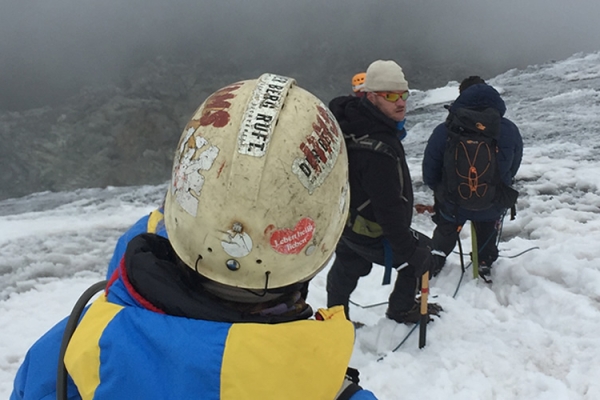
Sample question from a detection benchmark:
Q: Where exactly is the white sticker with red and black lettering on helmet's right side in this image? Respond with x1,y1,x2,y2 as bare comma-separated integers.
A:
292,104,342,194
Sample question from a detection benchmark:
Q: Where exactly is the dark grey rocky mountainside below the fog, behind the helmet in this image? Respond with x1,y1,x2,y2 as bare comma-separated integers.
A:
0,58,468,200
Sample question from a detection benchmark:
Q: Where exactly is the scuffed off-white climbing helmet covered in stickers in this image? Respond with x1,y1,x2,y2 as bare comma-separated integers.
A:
165,74,349,289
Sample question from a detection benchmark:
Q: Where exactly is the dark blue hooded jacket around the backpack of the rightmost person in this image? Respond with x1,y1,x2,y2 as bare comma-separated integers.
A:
423,83,523,222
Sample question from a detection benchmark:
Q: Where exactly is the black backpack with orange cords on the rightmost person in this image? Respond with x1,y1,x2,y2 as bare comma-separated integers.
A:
439,108,504,211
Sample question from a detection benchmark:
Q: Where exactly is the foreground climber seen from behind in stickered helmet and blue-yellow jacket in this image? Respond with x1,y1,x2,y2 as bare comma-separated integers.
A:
11,74,375,400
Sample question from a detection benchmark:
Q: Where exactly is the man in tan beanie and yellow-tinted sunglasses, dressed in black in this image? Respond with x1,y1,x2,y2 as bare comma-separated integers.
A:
327,60,441,323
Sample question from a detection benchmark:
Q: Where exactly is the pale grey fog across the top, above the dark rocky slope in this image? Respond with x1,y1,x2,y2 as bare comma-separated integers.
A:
0,0,600,111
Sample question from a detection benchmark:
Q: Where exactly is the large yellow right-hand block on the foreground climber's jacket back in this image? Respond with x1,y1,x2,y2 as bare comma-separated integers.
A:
221,306,354,400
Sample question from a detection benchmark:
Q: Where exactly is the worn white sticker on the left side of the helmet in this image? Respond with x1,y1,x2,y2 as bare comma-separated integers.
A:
171,127,219,217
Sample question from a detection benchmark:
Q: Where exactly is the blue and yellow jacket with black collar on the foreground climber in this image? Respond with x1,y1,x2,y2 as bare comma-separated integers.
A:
11,235,375,400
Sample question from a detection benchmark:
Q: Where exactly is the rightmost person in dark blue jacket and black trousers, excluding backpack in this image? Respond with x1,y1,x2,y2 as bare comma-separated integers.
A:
423,76,523,279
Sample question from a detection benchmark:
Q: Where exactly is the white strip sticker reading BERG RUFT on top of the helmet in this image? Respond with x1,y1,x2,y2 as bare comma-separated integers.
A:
238,74,295,157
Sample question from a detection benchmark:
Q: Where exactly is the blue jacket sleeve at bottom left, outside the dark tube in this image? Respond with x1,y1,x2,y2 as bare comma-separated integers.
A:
10,318,81,400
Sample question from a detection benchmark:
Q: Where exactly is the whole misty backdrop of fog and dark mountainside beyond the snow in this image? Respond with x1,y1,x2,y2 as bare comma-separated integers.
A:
0,0,600,199
